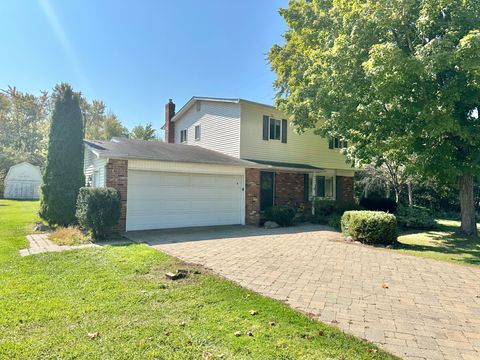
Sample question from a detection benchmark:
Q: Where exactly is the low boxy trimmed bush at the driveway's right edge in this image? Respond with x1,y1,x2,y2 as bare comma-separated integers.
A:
341,211,398,245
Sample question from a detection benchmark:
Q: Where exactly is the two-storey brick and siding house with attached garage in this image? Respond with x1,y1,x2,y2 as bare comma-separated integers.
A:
85,97,354,231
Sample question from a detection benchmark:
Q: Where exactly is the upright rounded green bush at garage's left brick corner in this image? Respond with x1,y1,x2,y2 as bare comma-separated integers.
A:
76,187,121,239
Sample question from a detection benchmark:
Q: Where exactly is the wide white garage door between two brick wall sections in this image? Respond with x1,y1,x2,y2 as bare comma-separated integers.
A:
127,170,243,231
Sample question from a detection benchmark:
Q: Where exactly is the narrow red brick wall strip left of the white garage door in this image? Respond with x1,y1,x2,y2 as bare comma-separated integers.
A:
106,159,128,232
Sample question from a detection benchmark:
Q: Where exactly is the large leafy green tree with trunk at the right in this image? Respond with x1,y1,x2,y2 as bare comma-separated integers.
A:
269,0,480,235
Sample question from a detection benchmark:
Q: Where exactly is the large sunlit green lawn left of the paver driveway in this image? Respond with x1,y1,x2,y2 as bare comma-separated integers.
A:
0,200,394,359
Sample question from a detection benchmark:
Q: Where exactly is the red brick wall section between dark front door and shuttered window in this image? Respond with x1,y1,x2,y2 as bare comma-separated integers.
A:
275,172,305,207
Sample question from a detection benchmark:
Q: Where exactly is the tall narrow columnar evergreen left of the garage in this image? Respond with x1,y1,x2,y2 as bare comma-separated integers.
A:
40,84,85,226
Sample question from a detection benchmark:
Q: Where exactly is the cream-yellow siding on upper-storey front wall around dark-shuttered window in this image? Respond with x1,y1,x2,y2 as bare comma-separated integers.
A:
240,103,353,173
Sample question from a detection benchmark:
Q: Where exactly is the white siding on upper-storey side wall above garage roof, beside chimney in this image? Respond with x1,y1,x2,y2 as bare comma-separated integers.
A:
175,101,240,158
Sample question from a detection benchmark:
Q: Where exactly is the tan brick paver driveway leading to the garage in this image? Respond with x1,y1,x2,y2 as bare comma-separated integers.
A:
129,226,480,359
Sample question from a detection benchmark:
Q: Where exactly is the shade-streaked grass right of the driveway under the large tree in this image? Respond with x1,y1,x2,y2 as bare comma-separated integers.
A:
396,220,480,265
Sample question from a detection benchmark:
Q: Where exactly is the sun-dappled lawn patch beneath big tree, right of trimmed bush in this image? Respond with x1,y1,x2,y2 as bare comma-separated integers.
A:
396,222,480,265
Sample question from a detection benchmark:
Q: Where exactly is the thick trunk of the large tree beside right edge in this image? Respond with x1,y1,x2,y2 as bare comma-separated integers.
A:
458,175,477,237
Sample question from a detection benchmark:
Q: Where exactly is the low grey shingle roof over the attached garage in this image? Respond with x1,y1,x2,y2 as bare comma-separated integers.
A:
84,138,259,167
